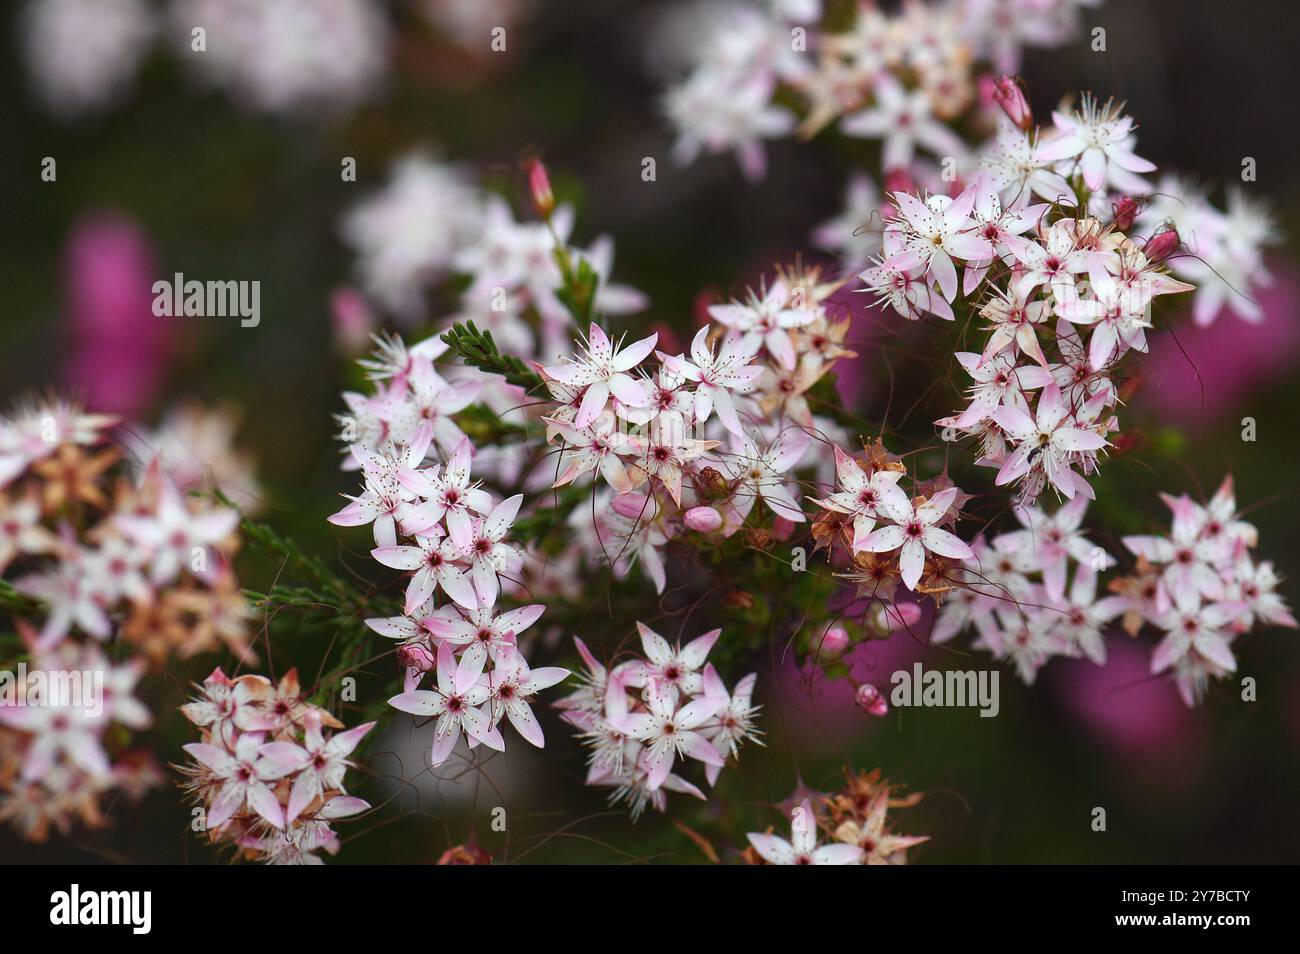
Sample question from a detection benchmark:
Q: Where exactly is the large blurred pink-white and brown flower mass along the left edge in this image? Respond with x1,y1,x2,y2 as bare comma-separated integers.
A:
0,400,254,838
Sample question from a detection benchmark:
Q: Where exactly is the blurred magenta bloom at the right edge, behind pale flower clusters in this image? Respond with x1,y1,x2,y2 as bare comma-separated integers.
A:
1139,264,1300,424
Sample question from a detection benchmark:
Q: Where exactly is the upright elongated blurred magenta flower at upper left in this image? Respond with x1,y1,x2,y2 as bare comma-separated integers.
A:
62,212,172,417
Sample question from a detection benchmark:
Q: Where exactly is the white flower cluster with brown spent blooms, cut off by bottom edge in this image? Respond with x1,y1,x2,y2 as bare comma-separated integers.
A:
745,768,930,864
